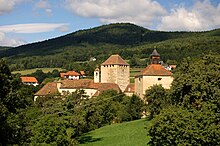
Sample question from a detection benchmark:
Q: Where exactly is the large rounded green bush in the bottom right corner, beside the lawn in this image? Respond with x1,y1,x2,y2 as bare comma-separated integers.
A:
148,105,220,146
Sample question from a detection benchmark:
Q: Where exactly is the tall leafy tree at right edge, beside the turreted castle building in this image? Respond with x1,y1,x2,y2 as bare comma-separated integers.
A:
171,55,220,108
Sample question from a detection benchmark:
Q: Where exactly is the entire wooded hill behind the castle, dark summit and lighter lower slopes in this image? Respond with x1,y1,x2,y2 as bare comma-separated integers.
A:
0,23,220,70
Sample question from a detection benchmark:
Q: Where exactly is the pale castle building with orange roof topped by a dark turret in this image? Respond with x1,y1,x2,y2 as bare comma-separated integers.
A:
135,49,173,99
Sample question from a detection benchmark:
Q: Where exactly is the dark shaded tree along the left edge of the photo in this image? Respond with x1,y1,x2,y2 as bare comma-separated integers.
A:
0,60,33,145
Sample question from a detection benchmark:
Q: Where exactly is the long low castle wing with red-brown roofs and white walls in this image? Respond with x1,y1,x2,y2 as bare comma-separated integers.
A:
34,79,121,101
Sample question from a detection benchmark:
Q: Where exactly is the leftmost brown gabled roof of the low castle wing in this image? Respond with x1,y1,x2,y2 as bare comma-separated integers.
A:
34,82,58,96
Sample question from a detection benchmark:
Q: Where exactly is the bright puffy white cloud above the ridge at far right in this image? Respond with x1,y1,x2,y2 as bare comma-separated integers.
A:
158,0,220,31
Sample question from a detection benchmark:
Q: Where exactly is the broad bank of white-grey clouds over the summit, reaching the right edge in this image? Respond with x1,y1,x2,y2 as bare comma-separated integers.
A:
65,0,220,31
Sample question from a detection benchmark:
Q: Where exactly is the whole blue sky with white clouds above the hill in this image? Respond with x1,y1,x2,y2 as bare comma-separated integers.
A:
0,0,220,47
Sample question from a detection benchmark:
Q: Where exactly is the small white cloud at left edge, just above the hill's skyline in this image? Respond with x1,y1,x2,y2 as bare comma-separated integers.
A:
0,32,26,47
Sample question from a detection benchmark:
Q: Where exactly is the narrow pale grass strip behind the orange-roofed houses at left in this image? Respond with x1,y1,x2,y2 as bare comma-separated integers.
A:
12,68,64,75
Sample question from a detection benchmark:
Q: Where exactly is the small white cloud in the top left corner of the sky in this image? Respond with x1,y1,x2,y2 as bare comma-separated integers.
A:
0,0,26,15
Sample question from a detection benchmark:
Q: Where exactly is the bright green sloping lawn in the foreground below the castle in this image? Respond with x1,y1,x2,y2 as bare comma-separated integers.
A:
80,119,150,146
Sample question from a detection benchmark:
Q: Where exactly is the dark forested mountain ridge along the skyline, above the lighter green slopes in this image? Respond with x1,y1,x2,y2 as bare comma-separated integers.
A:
0,23,220,57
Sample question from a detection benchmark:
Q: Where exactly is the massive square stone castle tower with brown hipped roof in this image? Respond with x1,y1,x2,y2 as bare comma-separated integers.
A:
101,55,130,92
